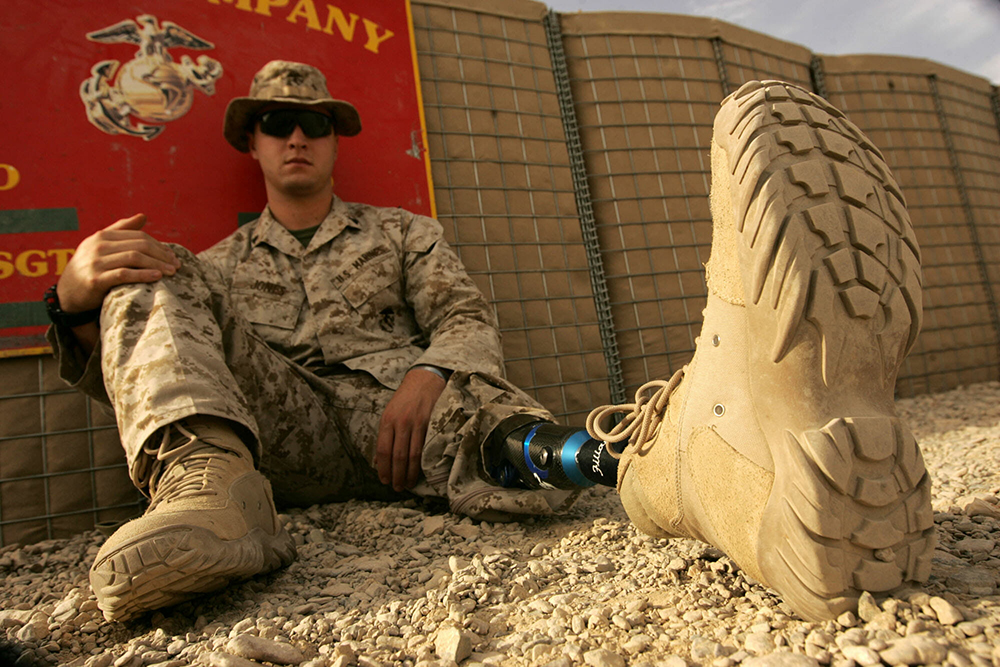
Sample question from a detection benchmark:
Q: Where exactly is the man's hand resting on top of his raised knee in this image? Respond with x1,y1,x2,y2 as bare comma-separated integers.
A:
56,213,181,313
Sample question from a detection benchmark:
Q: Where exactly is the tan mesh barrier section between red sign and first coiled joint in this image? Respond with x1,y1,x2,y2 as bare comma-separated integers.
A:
413,2,609,424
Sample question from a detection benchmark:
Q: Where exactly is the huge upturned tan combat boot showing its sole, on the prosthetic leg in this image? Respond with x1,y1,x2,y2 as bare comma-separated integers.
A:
588,81,935,620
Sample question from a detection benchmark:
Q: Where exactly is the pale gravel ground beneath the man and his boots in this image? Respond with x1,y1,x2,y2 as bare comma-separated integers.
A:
0,382,1000,667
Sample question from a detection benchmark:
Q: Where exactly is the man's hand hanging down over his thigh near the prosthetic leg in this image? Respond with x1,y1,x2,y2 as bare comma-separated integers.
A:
375,368,446,491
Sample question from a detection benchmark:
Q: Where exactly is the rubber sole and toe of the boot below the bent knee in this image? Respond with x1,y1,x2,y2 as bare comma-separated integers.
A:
90,525,295,621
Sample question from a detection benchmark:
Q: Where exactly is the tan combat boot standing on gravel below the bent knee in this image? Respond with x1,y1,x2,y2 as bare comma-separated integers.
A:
90,417,295,621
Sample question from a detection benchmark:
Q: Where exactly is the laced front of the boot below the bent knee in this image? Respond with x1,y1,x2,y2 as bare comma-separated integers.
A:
144,422,236,509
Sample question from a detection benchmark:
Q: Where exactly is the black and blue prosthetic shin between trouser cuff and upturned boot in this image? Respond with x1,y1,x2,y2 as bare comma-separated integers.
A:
484,414,618,489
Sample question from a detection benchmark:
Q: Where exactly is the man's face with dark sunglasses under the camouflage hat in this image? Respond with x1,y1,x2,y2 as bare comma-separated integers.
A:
249,106,337,197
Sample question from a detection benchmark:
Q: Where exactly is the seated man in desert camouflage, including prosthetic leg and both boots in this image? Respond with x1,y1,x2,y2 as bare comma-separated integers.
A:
47,61,932,620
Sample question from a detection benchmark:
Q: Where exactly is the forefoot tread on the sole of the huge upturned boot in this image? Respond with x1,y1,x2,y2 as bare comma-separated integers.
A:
720,82,921,376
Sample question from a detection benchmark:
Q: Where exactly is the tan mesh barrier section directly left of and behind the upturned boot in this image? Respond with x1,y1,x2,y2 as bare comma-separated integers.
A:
561,13,810,394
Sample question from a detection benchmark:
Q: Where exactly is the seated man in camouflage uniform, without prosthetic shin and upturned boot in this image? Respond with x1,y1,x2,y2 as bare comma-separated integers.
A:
47,61,614,620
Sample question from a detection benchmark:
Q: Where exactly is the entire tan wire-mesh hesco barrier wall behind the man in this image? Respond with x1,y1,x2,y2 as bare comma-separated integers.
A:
0,0,1000,545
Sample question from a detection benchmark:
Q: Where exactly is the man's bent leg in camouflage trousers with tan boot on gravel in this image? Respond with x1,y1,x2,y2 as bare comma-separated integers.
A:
91,248,372,620
